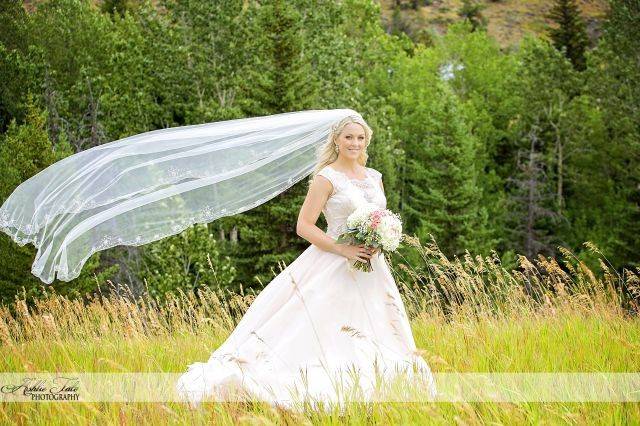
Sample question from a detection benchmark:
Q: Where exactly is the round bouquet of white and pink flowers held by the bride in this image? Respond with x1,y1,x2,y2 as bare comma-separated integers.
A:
336,203,402,272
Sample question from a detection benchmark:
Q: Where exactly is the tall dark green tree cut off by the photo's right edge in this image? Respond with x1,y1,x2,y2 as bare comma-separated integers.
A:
580,0,640,267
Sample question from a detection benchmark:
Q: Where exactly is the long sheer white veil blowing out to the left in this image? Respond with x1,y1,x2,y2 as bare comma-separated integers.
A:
0,109,360,284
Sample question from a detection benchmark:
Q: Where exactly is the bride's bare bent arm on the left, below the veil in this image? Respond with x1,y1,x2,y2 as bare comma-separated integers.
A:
296,176,344,256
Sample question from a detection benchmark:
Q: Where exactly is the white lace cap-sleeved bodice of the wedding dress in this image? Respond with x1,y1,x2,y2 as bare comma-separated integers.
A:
318,166,387,238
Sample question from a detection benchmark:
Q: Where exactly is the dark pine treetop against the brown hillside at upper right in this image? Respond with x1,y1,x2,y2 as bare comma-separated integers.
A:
548,0,589,71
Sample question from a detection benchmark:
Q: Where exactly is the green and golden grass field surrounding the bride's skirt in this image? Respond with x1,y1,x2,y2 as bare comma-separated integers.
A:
0,238,640,425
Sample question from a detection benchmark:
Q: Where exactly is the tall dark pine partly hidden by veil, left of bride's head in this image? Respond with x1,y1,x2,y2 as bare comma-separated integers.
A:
229,0,317,284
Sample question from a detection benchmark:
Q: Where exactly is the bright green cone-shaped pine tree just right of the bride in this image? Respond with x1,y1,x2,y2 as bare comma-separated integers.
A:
402,84,493,255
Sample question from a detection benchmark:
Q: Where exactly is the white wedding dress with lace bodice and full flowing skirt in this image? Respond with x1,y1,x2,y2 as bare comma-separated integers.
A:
176,166,436,409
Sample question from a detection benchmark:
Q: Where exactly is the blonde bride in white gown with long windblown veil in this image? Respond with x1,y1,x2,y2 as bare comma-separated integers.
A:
0,105,436,408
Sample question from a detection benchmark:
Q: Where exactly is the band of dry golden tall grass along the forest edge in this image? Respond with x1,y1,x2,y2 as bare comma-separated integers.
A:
0,235,640,347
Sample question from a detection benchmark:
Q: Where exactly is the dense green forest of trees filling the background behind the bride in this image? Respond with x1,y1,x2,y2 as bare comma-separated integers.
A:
0,0,640,297
